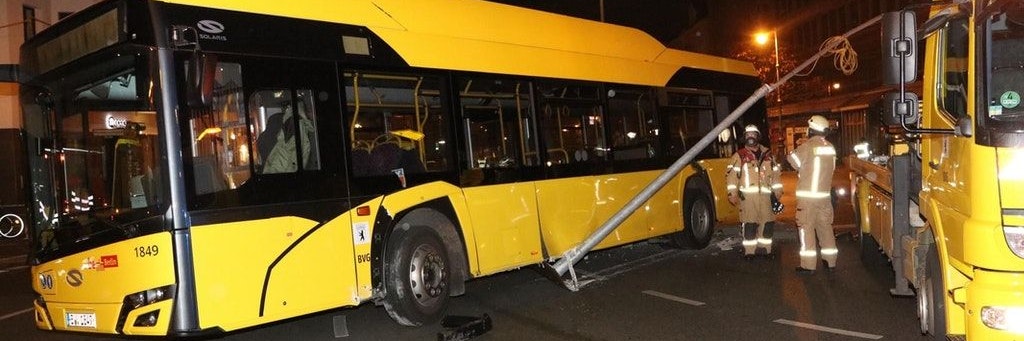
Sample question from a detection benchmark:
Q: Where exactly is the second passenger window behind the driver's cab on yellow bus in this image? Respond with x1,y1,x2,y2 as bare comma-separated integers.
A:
459,79,539,169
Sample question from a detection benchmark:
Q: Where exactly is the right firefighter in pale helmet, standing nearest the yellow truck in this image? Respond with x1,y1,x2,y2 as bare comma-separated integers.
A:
788,115,839,273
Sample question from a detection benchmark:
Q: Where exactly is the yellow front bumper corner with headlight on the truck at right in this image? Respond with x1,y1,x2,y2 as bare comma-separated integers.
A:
953,269,1024,340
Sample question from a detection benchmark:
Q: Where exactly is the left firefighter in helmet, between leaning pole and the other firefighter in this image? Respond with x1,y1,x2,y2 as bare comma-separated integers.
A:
726,124,782,259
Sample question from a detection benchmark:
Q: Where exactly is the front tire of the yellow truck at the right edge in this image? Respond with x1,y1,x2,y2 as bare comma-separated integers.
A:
918,246,946,340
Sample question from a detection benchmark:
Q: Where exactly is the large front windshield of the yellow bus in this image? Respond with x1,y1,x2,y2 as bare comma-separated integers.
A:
26,56,162,258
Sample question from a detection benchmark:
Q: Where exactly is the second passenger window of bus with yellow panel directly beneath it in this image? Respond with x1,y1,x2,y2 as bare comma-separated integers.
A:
457,77,544,273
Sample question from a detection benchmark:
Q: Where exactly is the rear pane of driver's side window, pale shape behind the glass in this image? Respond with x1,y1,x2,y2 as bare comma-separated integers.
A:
249,89,319,174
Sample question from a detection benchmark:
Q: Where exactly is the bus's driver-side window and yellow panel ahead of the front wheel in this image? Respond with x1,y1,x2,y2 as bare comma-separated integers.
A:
181,55,350,327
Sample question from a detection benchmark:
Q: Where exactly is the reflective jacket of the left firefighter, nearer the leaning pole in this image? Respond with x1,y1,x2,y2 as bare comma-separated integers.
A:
726,144,782,198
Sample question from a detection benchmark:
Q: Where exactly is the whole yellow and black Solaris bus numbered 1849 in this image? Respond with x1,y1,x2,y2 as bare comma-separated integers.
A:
20,0,766,336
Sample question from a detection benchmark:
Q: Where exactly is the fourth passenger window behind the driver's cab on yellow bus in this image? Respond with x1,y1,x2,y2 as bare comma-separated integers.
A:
607,87,658,160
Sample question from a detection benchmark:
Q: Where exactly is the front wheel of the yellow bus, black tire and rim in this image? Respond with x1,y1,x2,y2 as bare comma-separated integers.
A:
384,226,452,327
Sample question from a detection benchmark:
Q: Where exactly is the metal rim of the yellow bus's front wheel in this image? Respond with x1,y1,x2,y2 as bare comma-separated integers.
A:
409,241,447,306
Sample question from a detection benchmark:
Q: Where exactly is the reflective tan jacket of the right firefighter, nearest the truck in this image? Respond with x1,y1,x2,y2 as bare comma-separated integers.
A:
788,136,836,199
